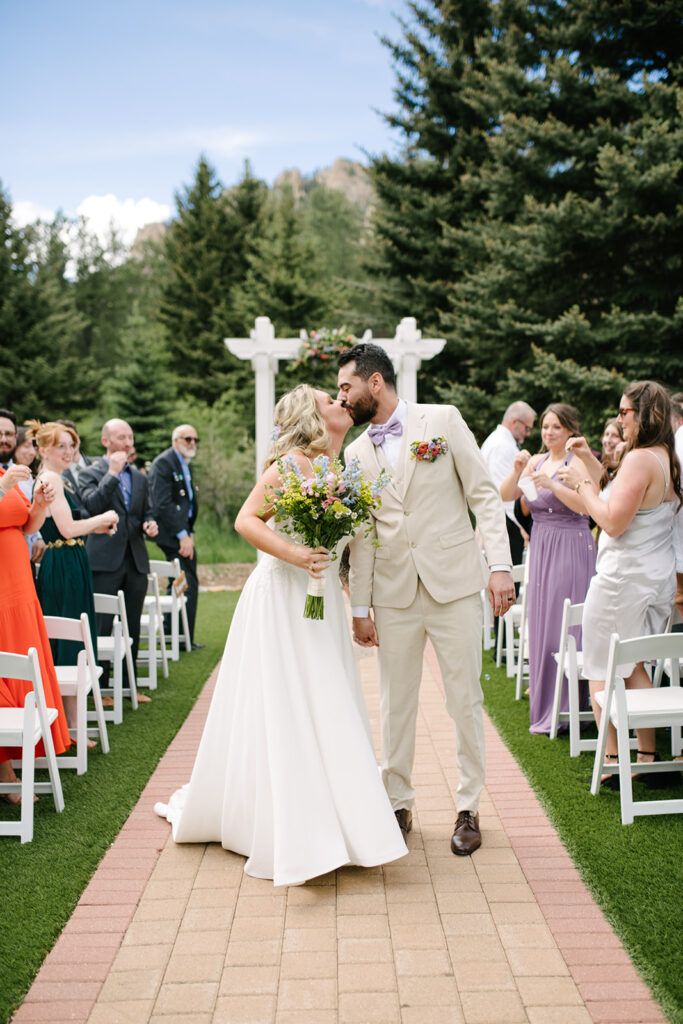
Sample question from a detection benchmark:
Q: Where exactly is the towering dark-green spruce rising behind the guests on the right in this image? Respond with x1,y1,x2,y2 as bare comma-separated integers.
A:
376,0,683,427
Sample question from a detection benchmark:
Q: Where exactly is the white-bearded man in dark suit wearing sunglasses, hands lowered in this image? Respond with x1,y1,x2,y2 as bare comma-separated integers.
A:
150,423,204,650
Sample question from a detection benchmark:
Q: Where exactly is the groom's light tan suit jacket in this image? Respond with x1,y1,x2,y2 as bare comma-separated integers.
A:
345,402,511,608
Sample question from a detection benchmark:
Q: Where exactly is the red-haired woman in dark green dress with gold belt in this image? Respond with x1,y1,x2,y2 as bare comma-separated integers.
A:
29,421,119,665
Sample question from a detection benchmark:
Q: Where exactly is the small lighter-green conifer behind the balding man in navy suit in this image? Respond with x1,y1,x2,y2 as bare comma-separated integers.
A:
104,303,177,462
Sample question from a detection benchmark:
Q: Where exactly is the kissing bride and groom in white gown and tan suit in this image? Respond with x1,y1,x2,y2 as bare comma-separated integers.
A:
155,343,515,885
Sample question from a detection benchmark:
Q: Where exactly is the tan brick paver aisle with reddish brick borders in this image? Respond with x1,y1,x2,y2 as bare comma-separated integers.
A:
14,649,665,1024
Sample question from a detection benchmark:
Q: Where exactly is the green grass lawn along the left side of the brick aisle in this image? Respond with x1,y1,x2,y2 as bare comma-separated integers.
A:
0,592,240,1022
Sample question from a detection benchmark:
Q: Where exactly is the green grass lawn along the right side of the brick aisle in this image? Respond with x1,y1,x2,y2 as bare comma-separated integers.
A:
482,652,683,1024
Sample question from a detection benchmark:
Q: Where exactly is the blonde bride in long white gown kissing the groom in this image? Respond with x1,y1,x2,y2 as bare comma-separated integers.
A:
155,384,408,886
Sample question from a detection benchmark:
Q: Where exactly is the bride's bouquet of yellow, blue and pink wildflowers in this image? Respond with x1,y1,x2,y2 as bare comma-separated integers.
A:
268,455,389,618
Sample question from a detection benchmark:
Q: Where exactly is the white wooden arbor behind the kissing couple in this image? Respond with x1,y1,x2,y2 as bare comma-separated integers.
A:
224,316,445,476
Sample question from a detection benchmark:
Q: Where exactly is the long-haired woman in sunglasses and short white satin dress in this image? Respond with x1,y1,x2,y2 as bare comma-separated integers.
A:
560,381,681,785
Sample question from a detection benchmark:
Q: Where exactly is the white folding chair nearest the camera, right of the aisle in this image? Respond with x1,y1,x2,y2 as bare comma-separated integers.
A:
591,633,683,825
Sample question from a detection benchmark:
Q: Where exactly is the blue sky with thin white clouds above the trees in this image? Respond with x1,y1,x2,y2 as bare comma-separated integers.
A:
0,0,407,240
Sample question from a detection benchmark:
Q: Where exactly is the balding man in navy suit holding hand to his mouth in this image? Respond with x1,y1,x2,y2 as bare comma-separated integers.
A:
78,420,159,675
